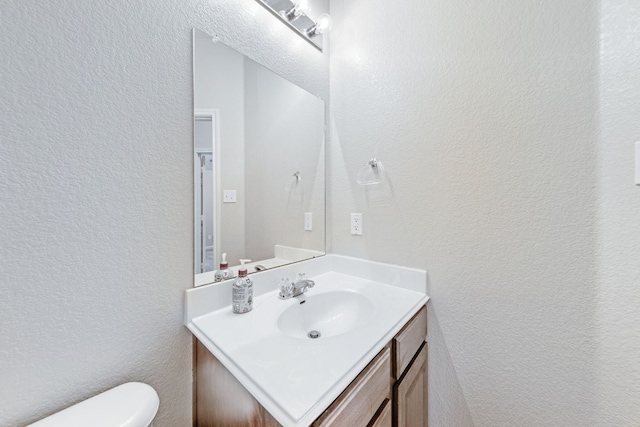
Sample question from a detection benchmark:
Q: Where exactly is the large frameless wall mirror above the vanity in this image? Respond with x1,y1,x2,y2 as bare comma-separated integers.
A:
193,29,325,286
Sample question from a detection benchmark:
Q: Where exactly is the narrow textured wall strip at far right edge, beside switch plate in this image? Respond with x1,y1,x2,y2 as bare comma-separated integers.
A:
598,0,640,426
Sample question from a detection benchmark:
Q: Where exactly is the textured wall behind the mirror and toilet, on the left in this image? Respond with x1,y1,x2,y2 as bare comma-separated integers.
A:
0,0,328,427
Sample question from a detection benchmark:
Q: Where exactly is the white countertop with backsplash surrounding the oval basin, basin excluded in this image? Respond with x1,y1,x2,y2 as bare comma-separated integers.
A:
186,255,428,427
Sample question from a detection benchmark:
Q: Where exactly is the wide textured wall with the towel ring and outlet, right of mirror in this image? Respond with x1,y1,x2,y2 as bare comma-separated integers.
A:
329,0,604,426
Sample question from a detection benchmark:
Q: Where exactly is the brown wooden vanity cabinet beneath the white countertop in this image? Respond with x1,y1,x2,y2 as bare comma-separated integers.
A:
194,306,428,427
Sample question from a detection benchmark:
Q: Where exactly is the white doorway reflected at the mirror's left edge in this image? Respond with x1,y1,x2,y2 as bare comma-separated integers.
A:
194,111,219,274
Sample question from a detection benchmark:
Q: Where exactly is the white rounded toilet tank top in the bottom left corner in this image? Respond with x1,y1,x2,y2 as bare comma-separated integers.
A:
29,382,160,427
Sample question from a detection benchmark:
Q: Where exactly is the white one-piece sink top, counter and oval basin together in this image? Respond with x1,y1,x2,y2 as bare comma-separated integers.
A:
187,264,428,427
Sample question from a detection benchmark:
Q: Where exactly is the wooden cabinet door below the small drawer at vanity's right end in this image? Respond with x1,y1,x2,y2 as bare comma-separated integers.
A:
394,342,428,427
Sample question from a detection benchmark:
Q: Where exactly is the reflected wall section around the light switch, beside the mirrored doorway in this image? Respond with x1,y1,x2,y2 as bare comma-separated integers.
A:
194,31,246,264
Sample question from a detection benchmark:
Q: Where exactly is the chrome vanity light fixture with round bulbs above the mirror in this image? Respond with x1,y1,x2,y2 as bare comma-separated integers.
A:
256,0,331,52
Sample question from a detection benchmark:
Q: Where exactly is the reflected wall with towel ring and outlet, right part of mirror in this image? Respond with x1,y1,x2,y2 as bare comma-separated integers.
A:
245,61,325,259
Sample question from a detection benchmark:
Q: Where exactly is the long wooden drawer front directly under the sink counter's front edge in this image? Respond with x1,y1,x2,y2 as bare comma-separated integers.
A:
313,347,391,427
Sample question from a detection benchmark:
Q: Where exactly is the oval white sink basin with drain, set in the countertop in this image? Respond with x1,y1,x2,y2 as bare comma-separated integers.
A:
278,290,374,339
